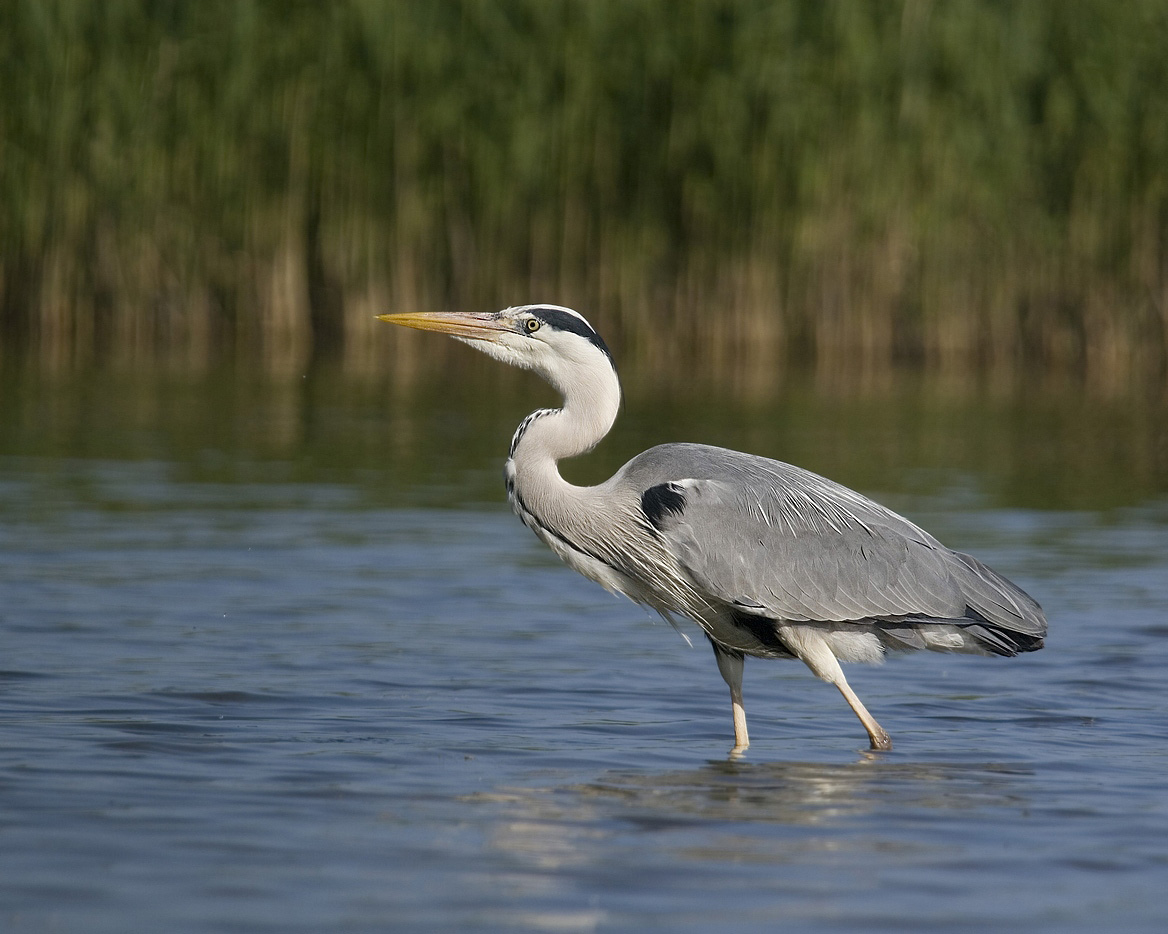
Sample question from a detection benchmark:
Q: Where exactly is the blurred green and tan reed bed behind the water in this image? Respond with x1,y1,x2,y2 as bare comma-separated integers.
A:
0,0,1168,381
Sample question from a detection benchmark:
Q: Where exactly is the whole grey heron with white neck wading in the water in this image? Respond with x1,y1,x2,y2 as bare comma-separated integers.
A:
378,305,1047,752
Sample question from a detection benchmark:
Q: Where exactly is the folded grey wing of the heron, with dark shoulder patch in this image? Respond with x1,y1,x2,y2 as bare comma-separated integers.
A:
642,445,1047,655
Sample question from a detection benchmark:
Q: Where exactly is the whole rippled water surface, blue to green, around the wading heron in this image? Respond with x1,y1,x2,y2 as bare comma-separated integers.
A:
0,368,1168,934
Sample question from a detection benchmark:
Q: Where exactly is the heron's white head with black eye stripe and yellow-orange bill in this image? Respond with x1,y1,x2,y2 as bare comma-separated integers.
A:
377,305,616,393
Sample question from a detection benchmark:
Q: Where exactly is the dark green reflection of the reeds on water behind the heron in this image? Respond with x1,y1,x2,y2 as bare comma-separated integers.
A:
0,361,1168,509
